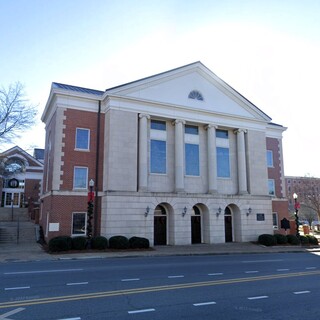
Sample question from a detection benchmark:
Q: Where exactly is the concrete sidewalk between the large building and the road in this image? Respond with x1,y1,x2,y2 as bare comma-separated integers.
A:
0,242,320,263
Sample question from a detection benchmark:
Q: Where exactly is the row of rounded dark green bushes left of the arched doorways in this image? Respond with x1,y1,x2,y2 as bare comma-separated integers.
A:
48,236,150,252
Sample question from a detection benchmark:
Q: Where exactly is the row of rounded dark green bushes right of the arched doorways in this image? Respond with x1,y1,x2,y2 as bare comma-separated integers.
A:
258,234,318,246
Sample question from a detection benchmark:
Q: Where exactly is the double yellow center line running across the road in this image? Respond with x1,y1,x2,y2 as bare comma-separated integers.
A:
0,270,320,309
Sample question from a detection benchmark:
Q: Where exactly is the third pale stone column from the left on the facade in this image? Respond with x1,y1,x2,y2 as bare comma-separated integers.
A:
206,124,218,193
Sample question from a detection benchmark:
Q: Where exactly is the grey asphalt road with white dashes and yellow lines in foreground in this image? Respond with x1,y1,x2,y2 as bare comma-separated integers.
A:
0,253,320,320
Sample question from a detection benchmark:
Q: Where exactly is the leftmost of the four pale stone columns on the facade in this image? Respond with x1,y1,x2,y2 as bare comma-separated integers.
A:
139,114,150,191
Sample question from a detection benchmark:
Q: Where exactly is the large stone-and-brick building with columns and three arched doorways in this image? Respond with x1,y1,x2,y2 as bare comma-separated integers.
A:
41,62,288,245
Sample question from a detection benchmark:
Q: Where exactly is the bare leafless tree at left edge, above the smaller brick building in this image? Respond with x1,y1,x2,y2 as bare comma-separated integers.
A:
0,82,37,143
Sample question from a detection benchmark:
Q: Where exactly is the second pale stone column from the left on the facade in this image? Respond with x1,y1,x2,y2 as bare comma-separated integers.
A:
174,120,186,192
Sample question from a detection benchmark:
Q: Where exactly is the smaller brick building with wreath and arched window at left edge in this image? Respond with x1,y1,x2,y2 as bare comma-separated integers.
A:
0,146,43,220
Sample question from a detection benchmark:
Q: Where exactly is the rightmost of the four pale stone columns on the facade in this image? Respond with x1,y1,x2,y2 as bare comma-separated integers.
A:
235,129,248,194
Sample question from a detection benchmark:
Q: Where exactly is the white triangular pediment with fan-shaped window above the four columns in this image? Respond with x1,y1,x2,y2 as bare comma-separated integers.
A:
105,62,271,122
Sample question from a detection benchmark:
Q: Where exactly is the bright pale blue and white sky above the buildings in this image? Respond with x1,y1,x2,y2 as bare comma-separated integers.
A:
0,0,320,177
